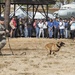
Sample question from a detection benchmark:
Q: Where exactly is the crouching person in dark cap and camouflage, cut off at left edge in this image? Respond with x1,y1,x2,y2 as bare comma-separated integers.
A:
0,17,8,55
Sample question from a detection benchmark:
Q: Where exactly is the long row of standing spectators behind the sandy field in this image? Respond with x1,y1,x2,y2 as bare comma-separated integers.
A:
9,17,75,39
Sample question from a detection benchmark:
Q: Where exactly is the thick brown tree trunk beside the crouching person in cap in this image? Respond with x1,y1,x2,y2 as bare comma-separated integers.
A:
4,0,11,29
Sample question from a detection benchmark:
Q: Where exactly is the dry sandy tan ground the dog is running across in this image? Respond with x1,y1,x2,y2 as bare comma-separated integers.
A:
0,38,75,75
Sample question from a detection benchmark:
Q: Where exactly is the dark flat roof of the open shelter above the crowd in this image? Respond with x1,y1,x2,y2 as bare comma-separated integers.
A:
0,0,56,5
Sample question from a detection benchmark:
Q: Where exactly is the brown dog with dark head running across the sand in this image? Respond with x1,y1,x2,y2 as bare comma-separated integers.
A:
45,42,65,55
